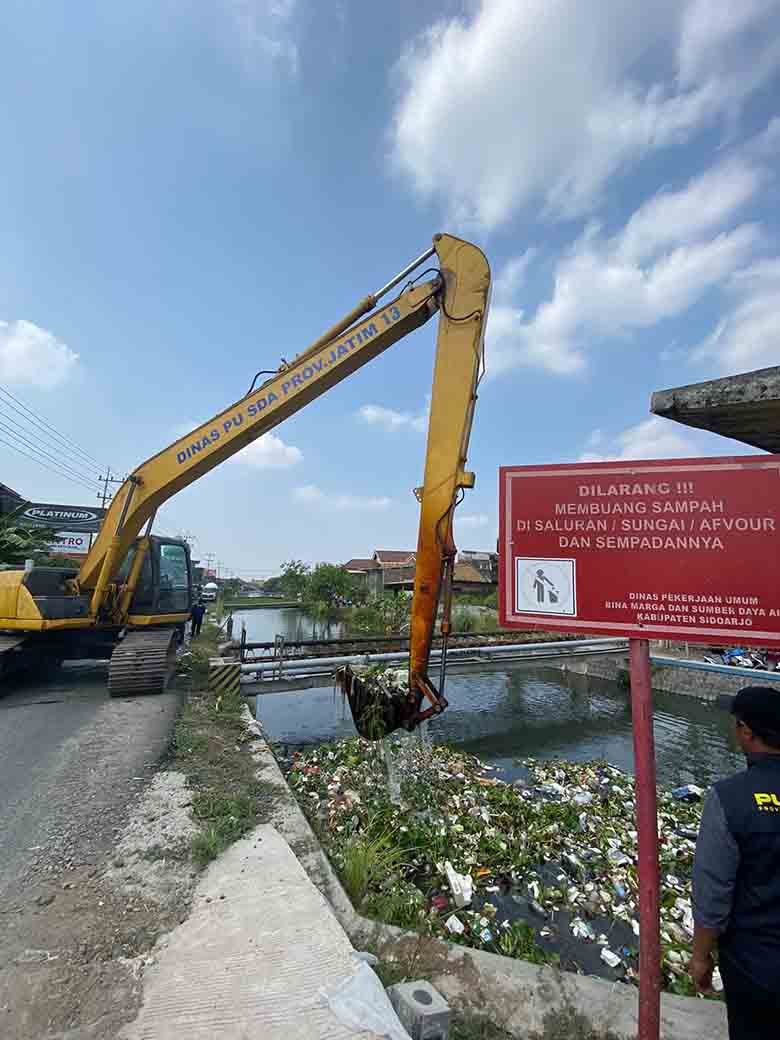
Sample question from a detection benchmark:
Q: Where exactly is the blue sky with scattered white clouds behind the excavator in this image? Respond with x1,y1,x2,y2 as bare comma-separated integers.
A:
0,0,780,574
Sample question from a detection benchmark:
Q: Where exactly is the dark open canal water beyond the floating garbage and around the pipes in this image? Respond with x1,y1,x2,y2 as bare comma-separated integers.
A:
241,610,745,785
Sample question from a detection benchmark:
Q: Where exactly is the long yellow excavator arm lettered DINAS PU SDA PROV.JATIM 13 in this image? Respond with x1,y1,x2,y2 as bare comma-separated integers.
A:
82,235,490,728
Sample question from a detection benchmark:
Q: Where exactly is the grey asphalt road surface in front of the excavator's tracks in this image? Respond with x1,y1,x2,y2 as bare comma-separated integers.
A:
0,662,182,909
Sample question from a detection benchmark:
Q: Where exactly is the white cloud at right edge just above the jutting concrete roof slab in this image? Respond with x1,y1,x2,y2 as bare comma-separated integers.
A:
693,258,780,374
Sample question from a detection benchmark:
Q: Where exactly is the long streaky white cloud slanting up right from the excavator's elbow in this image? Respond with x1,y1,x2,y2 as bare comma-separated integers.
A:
488,159,764,374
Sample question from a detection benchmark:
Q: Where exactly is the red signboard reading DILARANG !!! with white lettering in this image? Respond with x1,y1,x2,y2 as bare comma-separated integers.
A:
499,454,780,646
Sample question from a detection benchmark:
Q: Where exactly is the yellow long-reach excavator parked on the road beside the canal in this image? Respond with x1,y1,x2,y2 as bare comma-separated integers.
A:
0,235,490,729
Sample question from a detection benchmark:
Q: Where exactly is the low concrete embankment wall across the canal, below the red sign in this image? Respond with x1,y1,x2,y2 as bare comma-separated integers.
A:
561,654,780,701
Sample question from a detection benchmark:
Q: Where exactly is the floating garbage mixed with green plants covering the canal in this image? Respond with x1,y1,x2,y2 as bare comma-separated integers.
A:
283,736,715,994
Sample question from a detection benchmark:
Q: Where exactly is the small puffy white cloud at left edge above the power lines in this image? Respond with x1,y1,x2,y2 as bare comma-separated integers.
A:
0,320,79,390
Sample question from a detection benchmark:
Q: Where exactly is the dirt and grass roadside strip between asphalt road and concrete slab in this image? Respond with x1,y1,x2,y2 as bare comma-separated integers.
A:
0,631,269,1040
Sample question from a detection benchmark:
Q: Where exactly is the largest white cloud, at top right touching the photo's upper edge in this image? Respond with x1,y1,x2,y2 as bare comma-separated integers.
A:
391,0,780,229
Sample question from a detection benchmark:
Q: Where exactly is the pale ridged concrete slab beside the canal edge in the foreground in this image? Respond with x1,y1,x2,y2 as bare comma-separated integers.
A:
121,826,384,1040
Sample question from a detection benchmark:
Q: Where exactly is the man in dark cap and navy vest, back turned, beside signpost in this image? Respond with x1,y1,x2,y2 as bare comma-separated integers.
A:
690,686,780,1040
